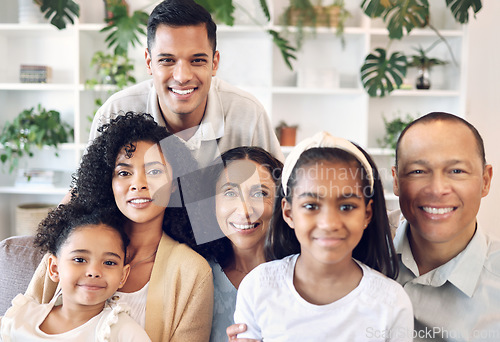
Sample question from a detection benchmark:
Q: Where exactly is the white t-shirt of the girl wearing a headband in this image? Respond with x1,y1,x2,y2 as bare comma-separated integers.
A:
234,254,413,342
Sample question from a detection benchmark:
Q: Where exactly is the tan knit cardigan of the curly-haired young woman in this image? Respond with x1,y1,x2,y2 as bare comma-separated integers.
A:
26,233,213,342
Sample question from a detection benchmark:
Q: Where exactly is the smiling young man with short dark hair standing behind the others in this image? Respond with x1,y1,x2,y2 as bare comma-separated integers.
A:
89,0,283,165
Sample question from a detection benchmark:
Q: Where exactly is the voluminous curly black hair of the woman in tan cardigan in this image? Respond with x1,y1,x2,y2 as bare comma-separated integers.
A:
72,112,198,247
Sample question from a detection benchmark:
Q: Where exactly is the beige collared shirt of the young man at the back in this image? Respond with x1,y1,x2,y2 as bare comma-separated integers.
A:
89,77,284,165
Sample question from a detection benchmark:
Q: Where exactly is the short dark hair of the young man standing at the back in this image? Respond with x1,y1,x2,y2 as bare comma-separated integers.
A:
147,0,217,54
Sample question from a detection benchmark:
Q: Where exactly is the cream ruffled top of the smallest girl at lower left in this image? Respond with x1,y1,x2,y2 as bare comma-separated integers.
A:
0,294,151,342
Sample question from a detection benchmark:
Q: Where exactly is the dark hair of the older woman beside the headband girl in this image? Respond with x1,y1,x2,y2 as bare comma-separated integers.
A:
197,146,283,268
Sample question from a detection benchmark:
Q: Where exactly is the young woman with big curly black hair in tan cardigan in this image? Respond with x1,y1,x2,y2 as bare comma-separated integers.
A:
27,113,213,342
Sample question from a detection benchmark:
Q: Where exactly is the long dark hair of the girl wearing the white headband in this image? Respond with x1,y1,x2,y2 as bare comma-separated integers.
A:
265,145,399,279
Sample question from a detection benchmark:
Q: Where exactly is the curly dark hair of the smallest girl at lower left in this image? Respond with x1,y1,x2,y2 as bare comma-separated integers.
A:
33,201,129,260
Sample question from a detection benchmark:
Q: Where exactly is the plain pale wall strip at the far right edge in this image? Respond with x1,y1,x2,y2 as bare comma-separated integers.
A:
466,0,500,237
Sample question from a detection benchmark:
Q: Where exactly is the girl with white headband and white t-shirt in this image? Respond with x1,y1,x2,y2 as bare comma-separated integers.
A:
234,132,413,342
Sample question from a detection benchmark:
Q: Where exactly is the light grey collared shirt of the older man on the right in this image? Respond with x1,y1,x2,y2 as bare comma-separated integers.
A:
394,221,500,342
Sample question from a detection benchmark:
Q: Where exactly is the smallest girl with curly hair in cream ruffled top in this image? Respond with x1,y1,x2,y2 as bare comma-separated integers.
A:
0,204,150,342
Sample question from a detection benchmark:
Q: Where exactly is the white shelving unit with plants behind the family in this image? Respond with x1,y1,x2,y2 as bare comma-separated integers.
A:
0,0,468,234
